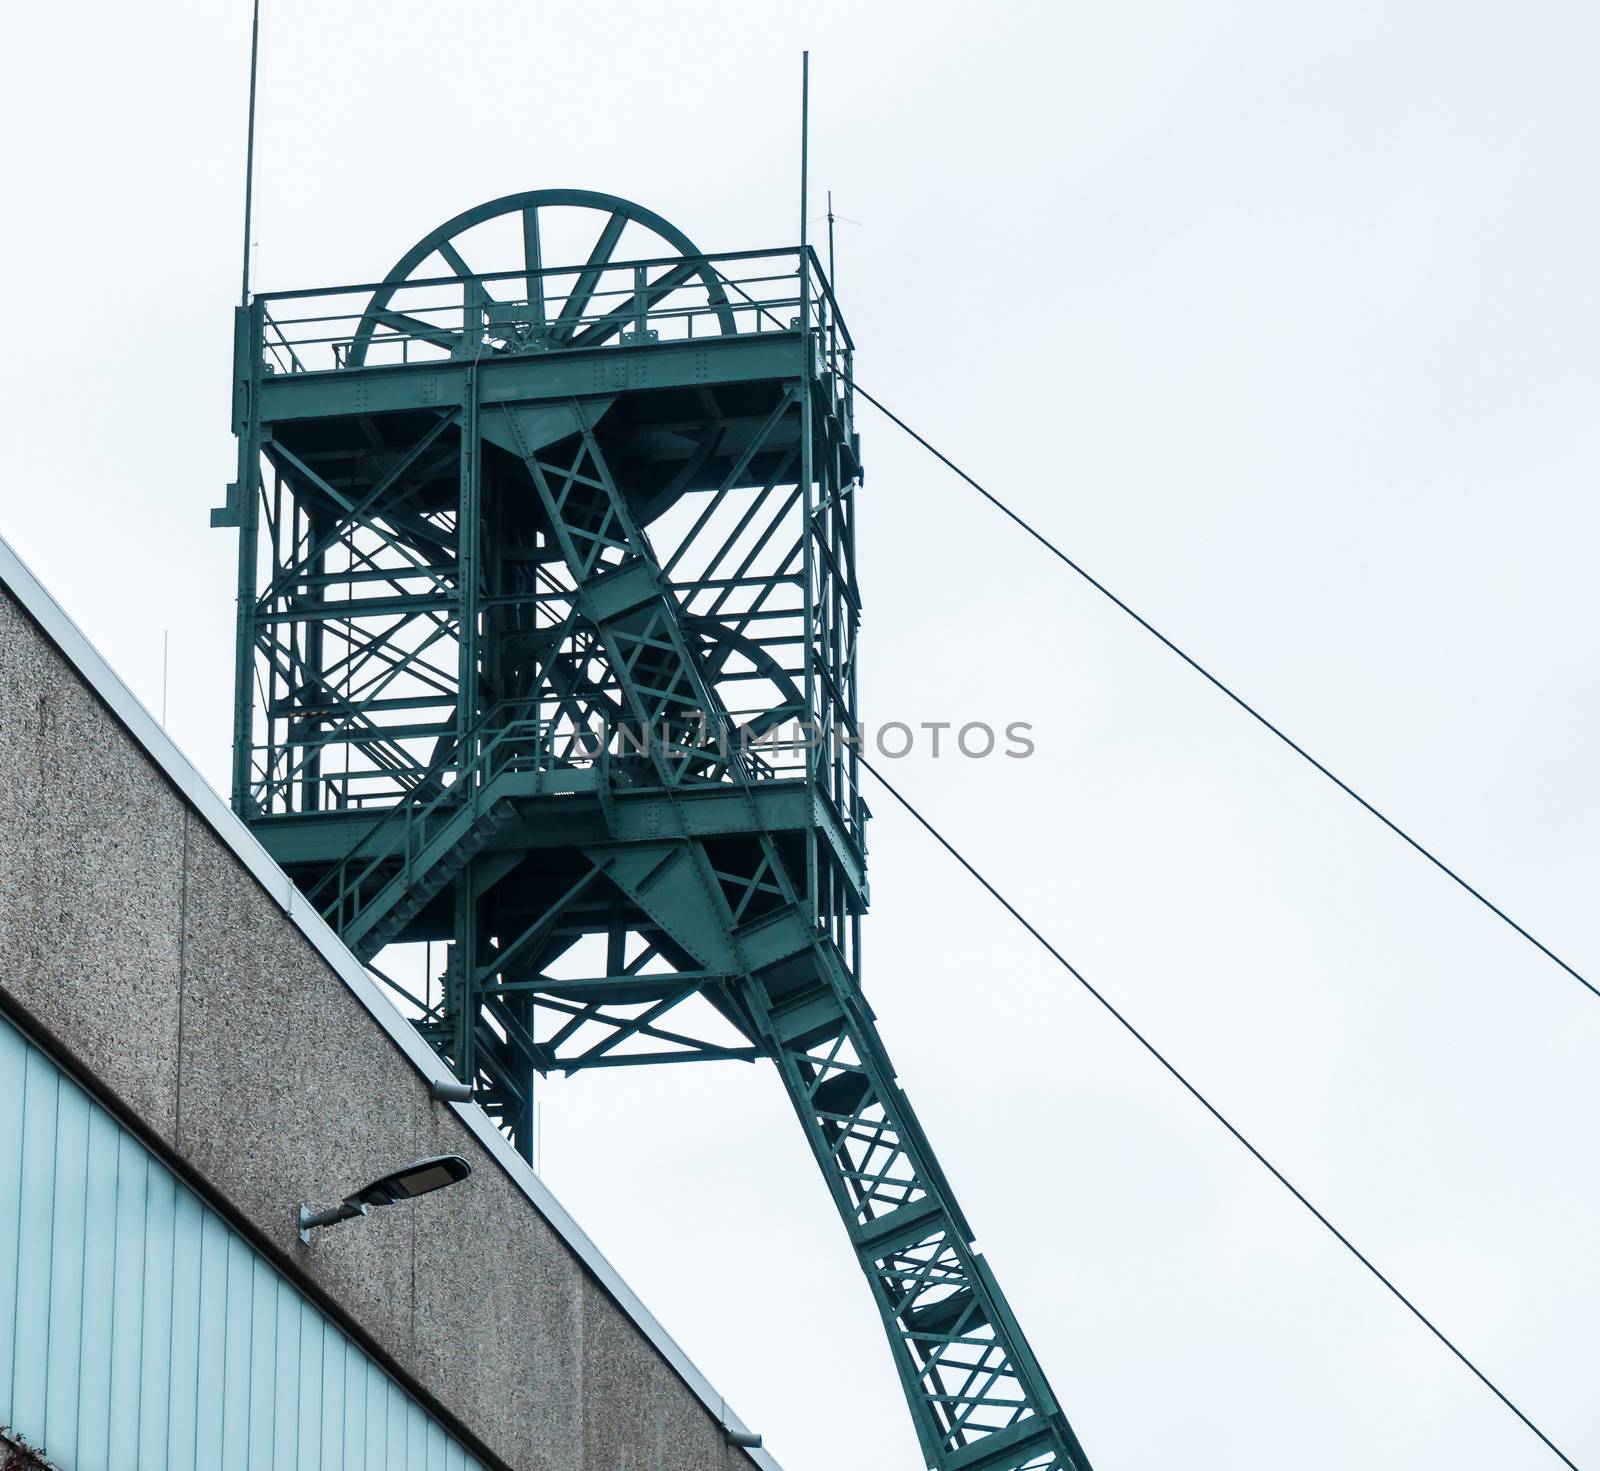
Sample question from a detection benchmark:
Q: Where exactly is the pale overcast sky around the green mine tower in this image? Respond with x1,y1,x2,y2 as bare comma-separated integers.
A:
0,0,1600,1471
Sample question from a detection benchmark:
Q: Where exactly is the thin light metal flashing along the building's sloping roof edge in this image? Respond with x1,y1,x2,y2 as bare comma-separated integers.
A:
0,536,782,1471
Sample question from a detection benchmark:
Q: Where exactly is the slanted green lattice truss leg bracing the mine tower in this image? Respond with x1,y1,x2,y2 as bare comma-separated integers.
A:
486,393,1086,1471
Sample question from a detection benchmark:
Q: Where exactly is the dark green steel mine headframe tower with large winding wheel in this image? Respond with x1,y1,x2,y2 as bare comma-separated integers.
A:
213,189,1088,1471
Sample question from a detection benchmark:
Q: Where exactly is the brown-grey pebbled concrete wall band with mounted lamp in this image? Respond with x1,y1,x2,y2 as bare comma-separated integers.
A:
0,560,776,1471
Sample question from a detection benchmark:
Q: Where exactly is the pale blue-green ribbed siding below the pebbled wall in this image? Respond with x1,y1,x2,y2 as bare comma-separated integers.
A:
0,1018,482,1471
